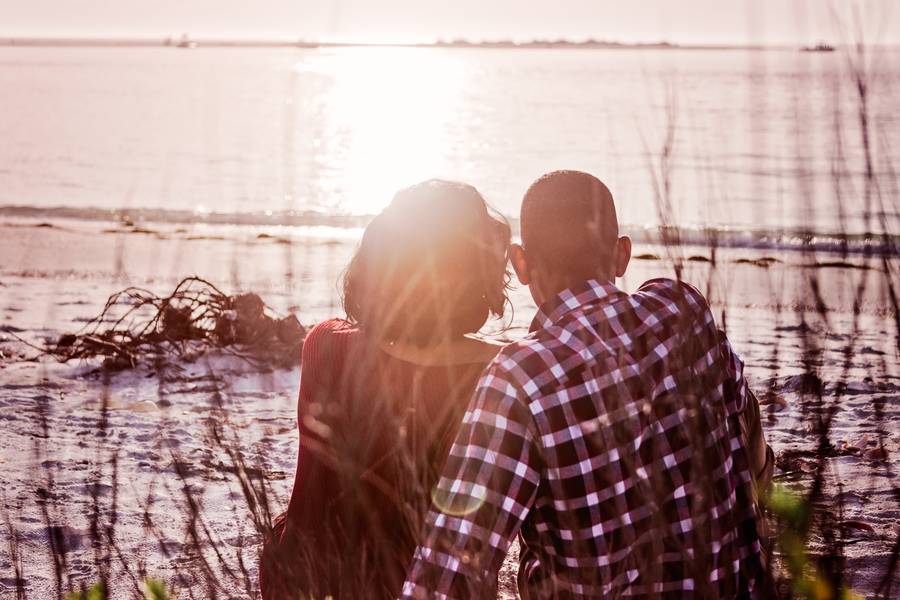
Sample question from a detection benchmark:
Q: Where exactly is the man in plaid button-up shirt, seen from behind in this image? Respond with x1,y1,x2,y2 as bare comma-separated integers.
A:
403,171,772,598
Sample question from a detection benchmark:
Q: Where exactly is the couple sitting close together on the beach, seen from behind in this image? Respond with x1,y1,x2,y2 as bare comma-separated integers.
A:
260,171,772,600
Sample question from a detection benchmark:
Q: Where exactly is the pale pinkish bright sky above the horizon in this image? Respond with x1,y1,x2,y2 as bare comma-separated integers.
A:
0,0,900,44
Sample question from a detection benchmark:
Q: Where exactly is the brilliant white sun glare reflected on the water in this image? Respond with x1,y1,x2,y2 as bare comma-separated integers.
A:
295,48,466,214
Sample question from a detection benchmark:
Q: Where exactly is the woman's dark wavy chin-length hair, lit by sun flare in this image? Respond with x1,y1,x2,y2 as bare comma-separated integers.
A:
343,179,510,345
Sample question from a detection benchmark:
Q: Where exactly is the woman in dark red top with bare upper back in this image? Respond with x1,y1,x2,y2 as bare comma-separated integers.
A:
260,180,510,600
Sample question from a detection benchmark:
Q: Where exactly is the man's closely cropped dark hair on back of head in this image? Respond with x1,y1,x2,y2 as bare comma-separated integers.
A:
521,171,619,279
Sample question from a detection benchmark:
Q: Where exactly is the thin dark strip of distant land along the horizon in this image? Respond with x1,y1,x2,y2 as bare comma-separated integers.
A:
0,37,788,50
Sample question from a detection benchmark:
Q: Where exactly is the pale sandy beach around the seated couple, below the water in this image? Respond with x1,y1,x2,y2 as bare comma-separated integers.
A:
0,219,900,598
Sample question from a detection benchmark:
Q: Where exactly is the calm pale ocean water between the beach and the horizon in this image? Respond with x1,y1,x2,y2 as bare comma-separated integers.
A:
0,47,900,236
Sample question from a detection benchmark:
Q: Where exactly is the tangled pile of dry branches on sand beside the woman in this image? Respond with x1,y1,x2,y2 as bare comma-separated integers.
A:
45,277,306,371
